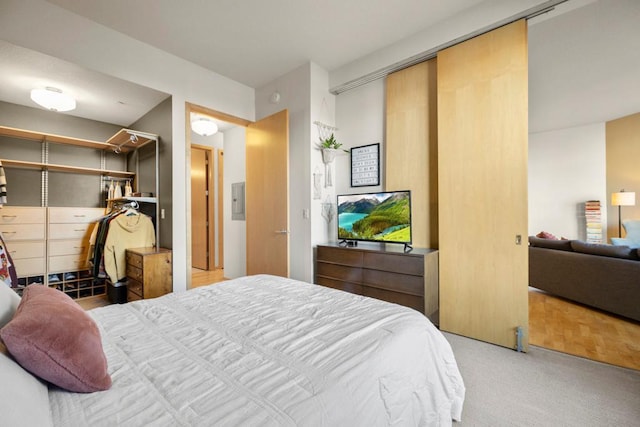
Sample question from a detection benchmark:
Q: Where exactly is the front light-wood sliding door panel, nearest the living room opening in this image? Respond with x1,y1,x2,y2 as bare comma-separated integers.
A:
438,20,528,351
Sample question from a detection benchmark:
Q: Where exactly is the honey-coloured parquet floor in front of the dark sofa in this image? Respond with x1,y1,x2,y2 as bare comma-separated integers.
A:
529,288,640,370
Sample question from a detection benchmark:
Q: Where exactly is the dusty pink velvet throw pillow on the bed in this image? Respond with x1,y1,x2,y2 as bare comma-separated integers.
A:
0,285,111,393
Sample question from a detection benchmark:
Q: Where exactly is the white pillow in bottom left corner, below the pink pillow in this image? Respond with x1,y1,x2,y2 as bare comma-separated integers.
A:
0,342,53,427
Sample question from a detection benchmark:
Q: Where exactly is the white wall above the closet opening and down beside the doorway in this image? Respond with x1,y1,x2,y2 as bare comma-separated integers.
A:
0,0,255,292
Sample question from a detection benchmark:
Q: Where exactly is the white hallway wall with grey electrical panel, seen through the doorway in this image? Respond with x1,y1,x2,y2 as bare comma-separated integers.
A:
223,126,247,279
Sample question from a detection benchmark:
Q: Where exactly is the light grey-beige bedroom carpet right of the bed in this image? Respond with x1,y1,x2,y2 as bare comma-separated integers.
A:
444,332,640,427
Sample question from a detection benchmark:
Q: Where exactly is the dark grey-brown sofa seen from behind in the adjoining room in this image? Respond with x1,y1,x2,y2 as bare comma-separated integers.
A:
529,236,640,321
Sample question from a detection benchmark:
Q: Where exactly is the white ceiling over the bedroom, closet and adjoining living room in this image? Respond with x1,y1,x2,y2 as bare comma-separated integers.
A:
0,0,640,132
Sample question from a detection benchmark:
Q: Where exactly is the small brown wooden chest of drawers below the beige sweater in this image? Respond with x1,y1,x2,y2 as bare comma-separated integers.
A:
126,248,173,301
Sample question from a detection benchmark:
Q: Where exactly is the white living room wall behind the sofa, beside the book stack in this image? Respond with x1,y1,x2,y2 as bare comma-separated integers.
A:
529,123,608,240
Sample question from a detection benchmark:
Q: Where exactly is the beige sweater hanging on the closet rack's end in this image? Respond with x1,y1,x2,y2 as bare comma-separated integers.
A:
104,213,156,283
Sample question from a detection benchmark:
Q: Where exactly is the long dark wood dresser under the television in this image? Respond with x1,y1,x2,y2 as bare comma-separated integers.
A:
316,242,438,324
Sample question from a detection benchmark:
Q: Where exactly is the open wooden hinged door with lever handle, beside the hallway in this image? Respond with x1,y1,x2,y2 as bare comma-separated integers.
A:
245,110,289,277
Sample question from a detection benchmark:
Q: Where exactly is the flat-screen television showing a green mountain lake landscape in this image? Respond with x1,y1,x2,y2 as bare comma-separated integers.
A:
338,190,411,251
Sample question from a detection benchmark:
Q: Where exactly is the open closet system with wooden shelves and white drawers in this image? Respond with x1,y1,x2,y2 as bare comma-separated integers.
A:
0,126,160,298
